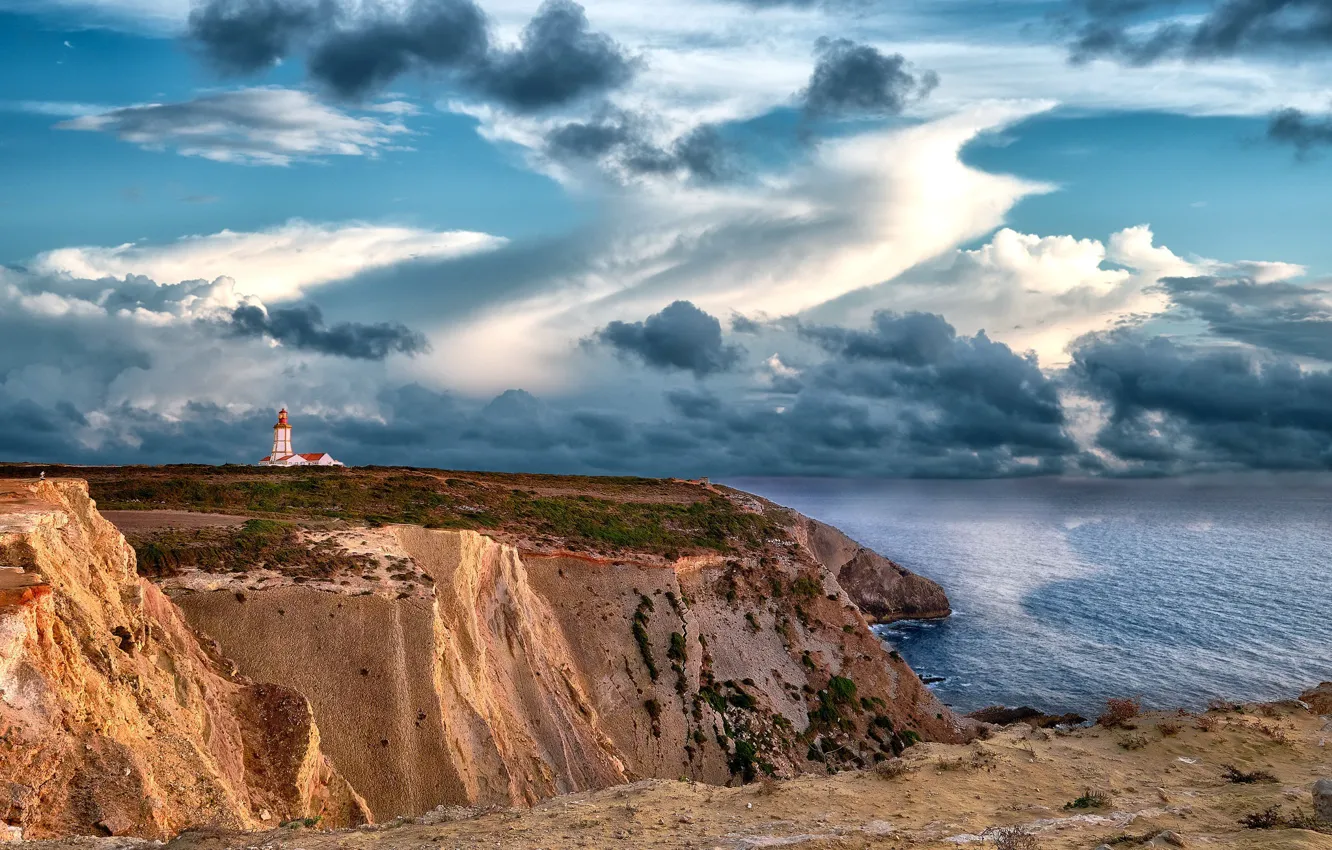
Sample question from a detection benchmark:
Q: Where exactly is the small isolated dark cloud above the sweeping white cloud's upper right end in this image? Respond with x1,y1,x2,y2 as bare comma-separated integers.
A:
801,39,939,116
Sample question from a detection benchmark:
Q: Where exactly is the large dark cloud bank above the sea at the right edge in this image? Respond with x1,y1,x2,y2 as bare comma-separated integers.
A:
1070,333,1332,474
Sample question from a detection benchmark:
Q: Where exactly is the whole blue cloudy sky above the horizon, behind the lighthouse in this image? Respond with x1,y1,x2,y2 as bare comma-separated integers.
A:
0,0,1332,478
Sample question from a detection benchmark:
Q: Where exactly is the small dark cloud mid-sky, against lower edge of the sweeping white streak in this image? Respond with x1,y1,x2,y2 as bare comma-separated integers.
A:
594,301,745,377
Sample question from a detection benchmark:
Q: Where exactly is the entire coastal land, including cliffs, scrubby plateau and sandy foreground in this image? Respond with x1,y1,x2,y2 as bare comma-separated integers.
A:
0,466,1332,850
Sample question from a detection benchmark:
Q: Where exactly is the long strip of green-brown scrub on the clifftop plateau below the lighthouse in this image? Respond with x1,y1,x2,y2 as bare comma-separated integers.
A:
44,466,785,557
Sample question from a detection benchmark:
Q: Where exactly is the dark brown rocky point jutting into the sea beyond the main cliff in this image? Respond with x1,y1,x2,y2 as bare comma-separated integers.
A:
793,512,952,624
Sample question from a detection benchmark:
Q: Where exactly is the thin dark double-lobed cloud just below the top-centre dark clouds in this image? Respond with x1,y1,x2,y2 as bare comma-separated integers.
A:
546,109,737,183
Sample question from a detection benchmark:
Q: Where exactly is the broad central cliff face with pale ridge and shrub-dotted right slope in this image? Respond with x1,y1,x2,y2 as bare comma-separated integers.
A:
167,506,967,819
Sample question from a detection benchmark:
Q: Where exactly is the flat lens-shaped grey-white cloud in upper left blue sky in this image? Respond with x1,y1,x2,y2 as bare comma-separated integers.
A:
56,88,408,165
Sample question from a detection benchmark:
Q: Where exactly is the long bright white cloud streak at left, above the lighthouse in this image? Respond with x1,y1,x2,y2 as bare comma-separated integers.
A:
28,221,505,301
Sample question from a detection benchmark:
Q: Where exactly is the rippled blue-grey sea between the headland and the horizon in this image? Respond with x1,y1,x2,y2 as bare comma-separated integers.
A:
727,476,1332,715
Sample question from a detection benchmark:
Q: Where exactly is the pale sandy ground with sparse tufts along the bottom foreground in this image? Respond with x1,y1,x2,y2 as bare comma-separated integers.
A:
18,703,1332,850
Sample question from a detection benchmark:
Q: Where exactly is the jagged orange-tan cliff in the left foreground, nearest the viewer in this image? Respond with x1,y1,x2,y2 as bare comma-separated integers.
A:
0,481,366,838
